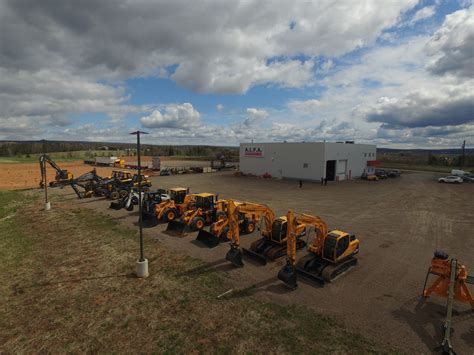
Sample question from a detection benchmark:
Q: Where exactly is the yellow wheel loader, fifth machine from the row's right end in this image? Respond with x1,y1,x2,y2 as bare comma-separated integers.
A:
155,187,195,222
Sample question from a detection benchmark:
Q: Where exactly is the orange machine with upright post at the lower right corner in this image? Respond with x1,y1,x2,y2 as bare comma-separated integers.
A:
423,251,474,354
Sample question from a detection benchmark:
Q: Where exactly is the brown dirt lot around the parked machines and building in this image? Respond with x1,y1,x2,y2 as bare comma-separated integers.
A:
45,173,474,354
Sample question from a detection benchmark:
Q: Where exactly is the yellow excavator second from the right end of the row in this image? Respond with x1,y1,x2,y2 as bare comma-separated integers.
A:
226,200,306,267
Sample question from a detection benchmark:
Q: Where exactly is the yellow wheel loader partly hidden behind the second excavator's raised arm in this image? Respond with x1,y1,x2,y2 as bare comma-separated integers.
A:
196,200,262,248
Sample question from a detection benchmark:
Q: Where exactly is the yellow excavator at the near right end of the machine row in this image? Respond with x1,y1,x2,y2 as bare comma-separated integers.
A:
278,210,359,290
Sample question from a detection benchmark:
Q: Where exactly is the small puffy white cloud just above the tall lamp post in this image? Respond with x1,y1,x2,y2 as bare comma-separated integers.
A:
140,102,201,130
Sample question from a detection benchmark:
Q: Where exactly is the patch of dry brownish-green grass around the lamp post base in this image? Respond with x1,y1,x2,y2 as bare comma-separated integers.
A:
0,192,391,354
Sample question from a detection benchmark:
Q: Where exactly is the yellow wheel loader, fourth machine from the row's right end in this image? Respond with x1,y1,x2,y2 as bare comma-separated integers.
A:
166,192,227,235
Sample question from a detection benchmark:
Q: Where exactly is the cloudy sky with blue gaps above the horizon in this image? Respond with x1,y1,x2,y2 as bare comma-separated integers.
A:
0,0,474,148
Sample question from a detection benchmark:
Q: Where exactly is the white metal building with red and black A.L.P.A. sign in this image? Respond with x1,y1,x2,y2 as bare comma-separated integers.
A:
240,142,377,181
